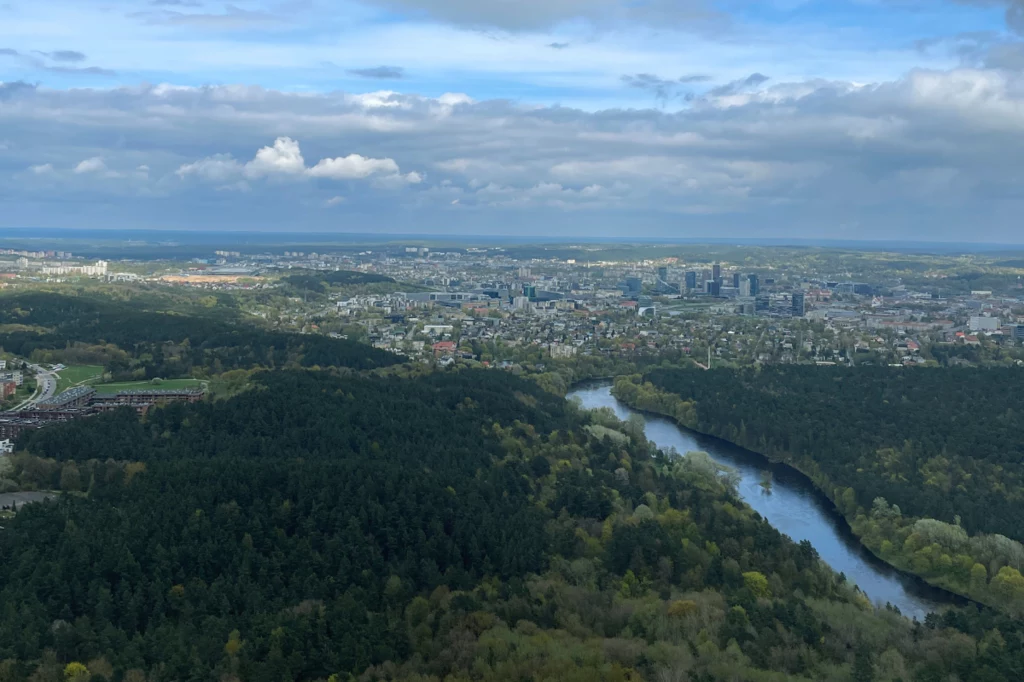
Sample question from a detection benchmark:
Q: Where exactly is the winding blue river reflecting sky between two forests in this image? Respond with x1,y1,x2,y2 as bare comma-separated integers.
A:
568,384,964,620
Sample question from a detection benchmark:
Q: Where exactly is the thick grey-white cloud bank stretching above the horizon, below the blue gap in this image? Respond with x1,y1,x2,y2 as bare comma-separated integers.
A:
0,69,1024,241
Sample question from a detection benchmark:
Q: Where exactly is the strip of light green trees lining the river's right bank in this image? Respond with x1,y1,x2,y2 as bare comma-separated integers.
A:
612,375,1024,617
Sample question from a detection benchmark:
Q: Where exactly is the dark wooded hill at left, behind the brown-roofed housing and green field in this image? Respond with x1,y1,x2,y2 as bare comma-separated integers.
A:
0,292,400,380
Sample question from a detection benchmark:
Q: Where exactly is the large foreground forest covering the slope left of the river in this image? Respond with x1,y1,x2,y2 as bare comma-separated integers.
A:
0,370,1024,682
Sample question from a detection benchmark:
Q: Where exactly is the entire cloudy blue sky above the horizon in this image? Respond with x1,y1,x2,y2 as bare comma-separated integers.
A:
0,0,1024,244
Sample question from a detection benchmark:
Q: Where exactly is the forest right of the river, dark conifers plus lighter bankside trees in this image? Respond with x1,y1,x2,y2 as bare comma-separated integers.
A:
615,366,1024,613
